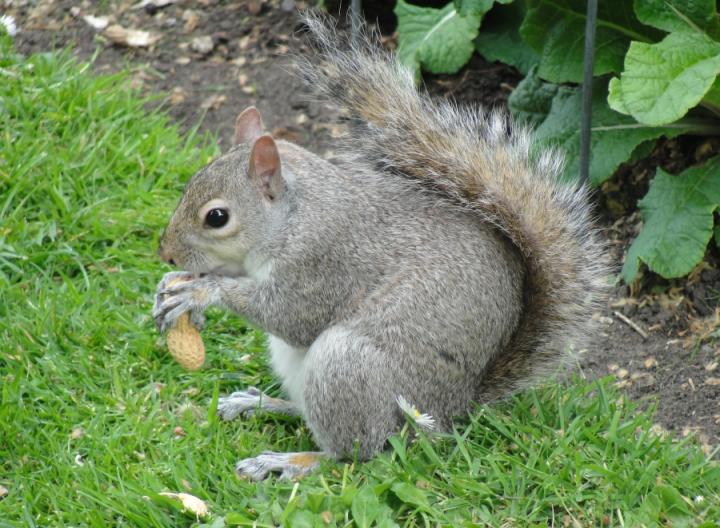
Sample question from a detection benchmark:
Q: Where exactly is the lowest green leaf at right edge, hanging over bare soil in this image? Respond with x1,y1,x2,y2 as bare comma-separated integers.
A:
622,157,720,282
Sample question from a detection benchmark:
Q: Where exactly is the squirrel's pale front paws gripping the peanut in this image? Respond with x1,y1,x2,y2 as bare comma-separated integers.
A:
152,271,220,332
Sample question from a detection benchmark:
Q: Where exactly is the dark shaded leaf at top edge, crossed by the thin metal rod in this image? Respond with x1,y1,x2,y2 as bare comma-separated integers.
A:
520,0,657,83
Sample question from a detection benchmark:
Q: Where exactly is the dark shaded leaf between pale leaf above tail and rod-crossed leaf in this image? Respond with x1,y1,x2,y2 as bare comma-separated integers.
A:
475,2,540,74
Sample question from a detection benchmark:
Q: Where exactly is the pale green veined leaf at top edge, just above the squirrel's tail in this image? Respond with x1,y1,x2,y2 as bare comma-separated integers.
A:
395,0,481,73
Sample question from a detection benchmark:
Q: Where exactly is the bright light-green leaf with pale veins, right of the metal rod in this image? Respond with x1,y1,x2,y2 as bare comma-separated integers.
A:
608,33,720,125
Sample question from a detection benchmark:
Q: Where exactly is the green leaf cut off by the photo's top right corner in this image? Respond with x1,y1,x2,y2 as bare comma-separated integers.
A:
634,0,720,39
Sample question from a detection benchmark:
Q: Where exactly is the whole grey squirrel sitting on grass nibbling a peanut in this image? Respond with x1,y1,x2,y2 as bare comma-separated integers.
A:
154,14,607,479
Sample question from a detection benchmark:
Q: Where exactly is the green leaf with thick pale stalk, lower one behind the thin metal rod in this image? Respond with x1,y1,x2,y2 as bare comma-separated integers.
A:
510,73,696,185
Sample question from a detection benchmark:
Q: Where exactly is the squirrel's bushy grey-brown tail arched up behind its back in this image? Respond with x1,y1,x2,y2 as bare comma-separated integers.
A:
301,14,607,401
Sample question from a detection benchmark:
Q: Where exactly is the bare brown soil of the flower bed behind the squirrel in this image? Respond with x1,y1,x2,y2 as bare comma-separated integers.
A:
7,0,720,451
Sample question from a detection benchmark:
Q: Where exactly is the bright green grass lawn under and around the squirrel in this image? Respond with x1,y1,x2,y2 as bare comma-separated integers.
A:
0,37,720,527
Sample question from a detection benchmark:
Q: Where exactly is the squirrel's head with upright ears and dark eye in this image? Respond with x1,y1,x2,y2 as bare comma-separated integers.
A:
158,107,287,276
